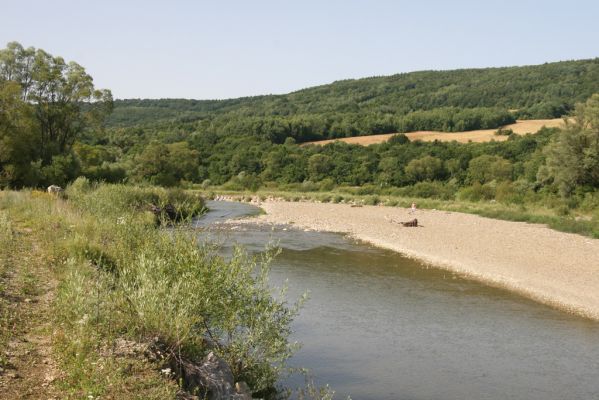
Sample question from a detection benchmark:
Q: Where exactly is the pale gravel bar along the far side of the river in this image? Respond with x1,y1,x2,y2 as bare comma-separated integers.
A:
239,201,599,320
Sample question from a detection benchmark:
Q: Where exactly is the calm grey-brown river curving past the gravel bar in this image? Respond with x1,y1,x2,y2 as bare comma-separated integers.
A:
198,202,599,400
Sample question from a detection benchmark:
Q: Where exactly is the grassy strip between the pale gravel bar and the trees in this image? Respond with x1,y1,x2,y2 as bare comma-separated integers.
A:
200,188,599,238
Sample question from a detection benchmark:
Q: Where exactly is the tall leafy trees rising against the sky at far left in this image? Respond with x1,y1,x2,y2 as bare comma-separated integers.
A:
0,42,112,187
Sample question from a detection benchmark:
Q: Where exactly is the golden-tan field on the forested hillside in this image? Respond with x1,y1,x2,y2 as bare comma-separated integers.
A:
304,118,564,146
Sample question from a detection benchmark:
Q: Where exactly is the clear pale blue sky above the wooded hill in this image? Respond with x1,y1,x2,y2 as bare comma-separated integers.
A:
0,0,599,99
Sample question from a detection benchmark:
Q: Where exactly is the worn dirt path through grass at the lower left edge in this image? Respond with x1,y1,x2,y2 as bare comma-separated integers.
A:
0,228,60,400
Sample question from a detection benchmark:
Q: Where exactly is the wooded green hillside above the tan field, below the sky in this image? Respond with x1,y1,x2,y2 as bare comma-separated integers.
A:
108,58,599,142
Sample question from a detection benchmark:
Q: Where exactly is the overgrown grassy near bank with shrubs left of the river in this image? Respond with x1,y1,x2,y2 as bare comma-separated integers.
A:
0,179,314,399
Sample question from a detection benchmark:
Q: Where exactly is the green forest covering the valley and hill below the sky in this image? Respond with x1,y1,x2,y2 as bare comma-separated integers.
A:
0,43,599,222
